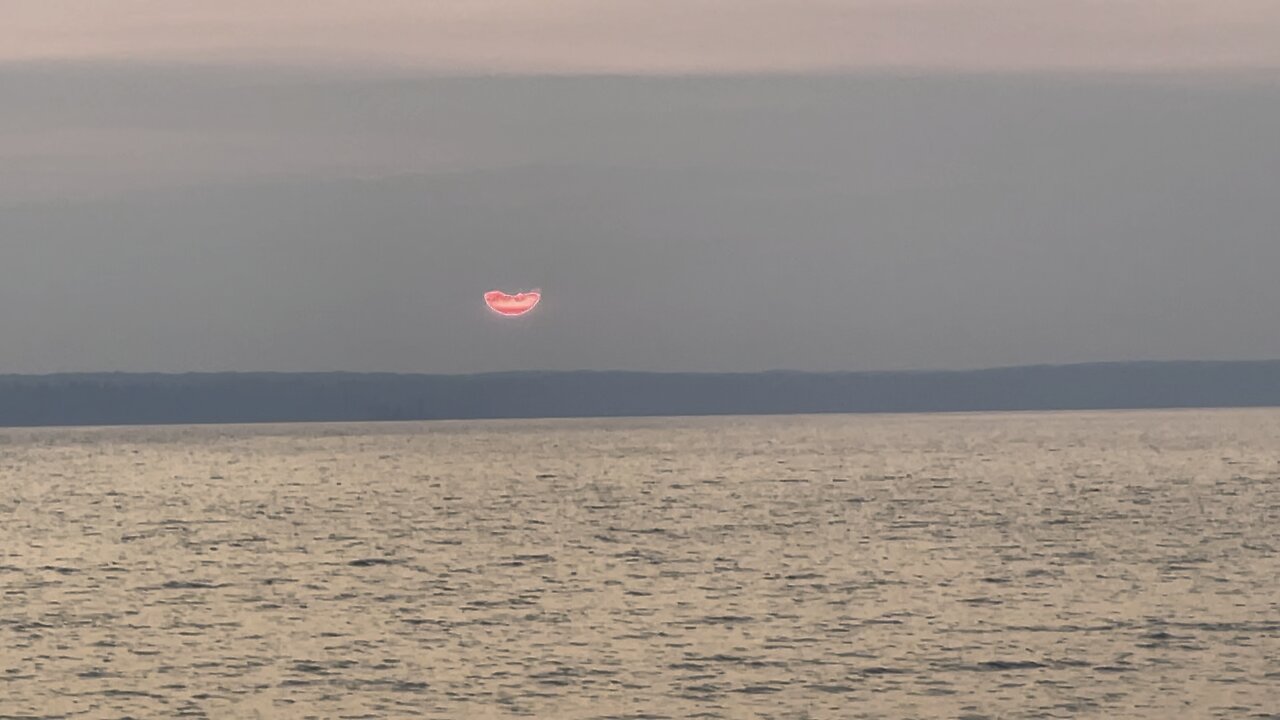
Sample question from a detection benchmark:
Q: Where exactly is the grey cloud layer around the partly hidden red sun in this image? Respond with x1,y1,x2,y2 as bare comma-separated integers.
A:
0,68,1280,372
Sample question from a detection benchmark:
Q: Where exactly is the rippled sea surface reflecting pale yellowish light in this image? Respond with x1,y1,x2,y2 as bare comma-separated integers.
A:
0,410,1280,720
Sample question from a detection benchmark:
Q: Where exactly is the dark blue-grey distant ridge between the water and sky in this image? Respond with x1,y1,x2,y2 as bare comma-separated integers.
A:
0,361,1280,427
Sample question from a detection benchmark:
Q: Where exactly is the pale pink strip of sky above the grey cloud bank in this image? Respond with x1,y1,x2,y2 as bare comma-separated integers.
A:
0,0,1280,73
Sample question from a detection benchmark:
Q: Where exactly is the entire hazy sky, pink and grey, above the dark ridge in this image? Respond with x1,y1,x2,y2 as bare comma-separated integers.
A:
0,0,1280,372
